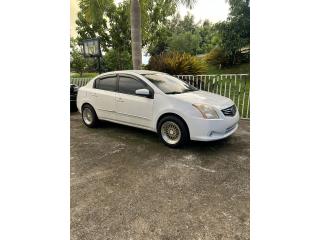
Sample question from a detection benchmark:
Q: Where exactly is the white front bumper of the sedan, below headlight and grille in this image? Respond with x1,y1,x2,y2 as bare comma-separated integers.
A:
188,111,239,141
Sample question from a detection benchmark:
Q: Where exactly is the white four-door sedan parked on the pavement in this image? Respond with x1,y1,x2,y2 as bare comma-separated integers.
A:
77,70,239,147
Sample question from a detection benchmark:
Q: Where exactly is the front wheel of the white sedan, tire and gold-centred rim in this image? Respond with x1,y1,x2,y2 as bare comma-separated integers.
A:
158,116,189,148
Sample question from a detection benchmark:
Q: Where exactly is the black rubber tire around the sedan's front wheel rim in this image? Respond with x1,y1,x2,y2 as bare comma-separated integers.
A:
157,115,190,148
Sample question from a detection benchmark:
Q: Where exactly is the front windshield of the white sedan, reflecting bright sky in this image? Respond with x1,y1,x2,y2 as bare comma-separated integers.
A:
143,73,198,94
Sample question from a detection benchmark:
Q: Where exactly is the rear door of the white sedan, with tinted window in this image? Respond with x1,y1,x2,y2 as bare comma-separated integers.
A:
94,75,117,120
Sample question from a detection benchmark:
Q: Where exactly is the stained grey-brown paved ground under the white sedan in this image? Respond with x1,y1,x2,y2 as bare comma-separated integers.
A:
71,113,250,240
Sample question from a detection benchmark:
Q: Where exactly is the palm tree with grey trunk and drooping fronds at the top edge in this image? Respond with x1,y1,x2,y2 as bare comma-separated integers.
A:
79,0,197,69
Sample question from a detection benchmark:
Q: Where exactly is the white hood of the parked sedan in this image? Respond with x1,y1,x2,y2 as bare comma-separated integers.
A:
169,91,234,109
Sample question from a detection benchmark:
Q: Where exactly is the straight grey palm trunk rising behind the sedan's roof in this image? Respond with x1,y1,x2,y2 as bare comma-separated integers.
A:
130,0,142,69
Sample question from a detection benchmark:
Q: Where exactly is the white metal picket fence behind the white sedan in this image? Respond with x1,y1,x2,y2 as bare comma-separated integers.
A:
71,74,250,119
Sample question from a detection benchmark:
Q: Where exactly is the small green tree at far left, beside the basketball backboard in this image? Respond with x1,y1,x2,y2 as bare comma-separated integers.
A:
70,38,86,76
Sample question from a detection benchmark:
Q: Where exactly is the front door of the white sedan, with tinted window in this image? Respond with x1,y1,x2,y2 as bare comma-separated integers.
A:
115,74,154,128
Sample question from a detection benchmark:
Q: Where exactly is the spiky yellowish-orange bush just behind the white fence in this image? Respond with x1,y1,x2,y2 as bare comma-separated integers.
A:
147,52,207,75
